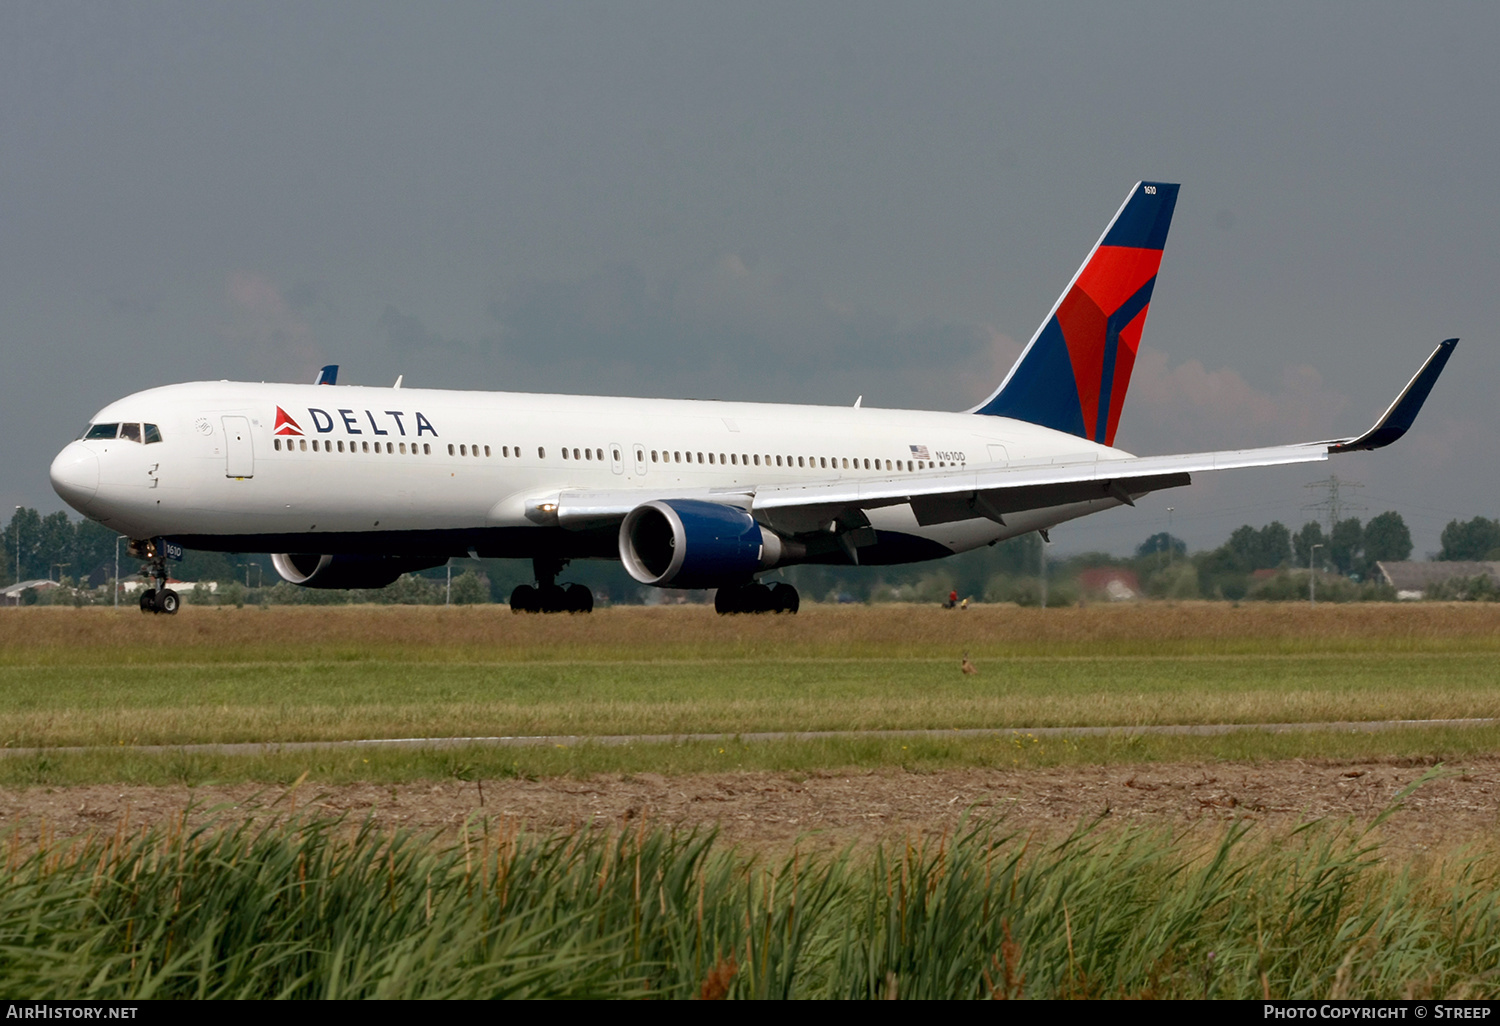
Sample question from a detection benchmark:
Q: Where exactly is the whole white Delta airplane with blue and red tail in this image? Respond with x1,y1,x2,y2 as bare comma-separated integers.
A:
51,182,1457,614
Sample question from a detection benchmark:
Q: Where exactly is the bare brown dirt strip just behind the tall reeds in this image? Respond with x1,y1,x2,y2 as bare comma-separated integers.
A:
0,756,1500,854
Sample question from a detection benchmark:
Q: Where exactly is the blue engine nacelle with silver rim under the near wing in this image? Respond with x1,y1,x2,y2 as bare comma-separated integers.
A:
620,500,782,588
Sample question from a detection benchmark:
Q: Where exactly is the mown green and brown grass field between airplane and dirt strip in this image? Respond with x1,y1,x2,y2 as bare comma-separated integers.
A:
0,603,1500,780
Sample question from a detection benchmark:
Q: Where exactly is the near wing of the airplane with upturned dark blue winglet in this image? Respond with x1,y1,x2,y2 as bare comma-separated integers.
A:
548,339,1458,534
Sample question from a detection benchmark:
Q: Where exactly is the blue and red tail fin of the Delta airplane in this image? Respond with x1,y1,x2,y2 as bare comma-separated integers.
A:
969,182,1178,446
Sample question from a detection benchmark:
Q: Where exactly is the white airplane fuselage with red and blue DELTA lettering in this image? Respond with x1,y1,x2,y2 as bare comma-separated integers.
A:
53,381,1128,563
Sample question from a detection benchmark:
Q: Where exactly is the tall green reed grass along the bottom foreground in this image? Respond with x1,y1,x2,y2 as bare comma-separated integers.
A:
0,780,1500,999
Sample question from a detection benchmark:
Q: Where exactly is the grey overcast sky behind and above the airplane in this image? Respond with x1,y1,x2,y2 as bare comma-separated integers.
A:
0,0,1500,555
